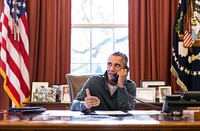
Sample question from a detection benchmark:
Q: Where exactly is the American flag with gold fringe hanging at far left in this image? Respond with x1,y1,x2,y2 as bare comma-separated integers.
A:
0,0,30,107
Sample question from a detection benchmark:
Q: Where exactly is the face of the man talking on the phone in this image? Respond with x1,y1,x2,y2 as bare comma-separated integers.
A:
107,55,125,81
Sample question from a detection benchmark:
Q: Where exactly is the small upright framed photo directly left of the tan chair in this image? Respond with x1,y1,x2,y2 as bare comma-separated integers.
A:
61,85,70,103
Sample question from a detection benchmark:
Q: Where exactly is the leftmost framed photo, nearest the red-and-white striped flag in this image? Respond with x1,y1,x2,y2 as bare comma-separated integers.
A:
31,82,49,102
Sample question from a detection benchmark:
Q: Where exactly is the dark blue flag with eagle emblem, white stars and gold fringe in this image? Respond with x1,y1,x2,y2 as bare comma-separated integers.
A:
170,0,200,91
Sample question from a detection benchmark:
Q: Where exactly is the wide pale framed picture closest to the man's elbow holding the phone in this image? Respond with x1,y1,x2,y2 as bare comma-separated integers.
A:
136,87,155,102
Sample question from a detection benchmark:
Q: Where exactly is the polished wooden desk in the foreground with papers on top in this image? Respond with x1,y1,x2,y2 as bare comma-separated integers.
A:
0,110,200,131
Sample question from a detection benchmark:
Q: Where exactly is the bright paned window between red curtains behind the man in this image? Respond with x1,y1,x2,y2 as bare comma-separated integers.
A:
71,0,128,74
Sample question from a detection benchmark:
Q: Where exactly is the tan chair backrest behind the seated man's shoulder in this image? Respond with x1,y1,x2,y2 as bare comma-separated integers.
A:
66,74,94,102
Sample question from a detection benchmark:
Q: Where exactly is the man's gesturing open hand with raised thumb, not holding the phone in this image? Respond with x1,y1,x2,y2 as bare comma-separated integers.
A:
84,89,100,109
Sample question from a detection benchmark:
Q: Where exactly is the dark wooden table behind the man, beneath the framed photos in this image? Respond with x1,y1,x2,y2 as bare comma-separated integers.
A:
23,102,163,110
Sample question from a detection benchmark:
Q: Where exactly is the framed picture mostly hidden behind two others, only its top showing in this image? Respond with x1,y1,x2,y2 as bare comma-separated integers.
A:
140,80,166,88
